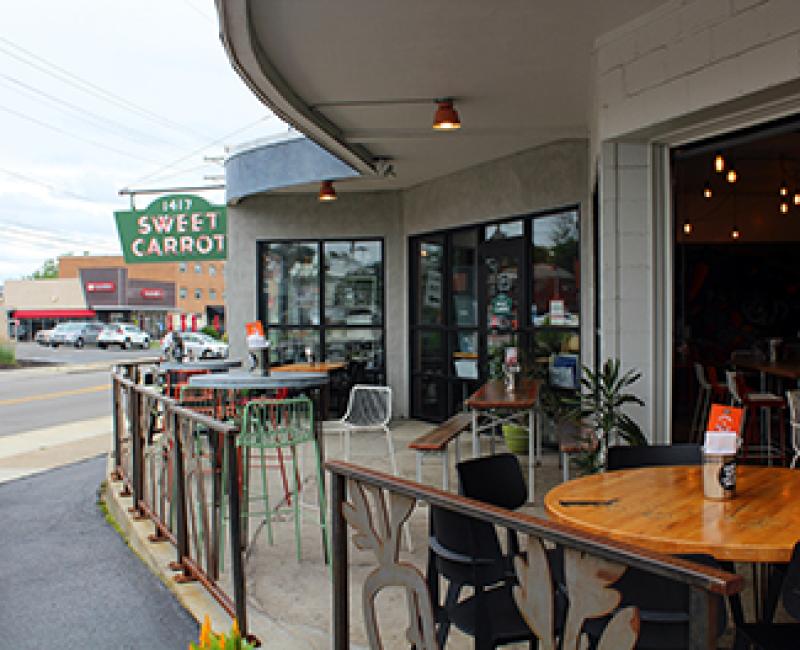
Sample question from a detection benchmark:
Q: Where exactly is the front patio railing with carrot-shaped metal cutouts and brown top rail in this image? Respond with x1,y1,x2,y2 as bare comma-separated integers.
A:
326,461,742,650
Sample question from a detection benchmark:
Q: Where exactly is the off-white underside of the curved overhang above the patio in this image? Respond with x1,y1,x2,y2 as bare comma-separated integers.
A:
219,0,664,189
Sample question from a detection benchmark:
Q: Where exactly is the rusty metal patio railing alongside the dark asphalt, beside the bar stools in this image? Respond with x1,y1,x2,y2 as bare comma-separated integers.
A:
111,364,248,635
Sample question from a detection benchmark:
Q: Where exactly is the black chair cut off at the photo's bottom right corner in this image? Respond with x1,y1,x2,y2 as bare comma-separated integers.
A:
734,542,800,650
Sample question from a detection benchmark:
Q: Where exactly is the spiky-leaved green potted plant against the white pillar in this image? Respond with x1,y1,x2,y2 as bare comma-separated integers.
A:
567,359,647,473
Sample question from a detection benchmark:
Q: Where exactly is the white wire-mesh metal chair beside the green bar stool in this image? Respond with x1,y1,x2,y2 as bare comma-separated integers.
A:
323,384,412,550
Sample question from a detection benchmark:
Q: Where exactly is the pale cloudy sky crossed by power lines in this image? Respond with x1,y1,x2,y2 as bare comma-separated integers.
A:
0,0,287,283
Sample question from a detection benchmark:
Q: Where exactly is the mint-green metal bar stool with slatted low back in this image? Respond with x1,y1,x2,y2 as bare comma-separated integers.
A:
236,396,330,561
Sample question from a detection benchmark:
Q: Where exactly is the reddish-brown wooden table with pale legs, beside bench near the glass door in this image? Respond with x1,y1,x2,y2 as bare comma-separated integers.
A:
465,379,541,503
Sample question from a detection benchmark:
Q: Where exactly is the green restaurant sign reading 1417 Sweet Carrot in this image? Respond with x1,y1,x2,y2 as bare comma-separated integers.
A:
114,194,228,264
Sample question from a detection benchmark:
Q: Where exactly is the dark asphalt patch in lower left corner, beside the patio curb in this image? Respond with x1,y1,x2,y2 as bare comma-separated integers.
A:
0,458,198,650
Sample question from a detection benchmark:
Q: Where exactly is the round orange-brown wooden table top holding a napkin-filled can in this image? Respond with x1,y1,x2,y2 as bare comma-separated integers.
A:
544,465,800,562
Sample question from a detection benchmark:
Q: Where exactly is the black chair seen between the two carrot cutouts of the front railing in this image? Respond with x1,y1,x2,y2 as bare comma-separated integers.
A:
427,506,536,650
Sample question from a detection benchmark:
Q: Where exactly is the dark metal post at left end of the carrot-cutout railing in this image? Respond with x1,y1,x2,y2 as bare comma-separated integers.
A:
330,472,350,650
